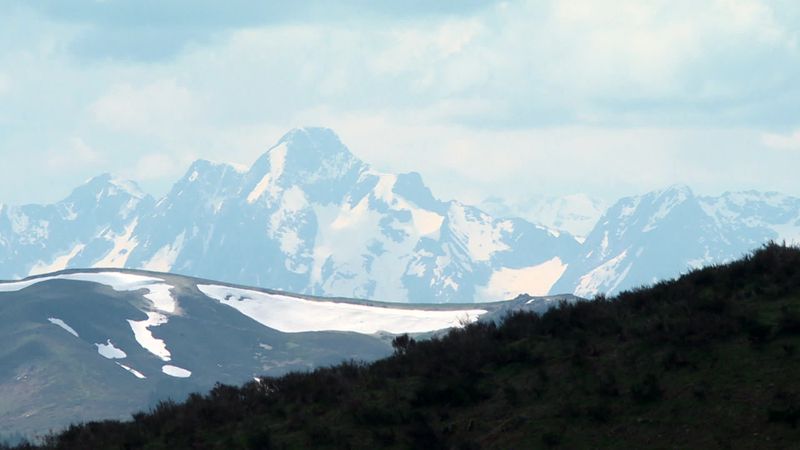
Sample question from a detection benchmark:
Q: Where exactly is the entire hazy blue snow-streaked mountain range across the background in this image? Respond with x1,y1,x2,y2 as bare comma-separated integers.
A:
0,128,800,303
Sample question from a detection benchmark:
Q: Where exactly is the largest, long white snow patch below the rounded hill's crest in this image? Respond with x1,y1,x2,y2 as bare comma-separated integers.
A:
197,285,487,334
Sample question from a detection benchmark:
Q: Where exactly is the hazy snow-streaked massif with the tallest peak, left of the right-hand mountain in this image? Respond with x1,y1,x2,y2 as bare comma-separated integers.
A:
0,128,579,302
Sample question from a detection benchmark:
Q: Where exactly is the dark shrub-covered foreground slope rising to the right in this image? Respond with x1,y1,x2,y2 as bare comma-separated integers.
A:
9,244,800,449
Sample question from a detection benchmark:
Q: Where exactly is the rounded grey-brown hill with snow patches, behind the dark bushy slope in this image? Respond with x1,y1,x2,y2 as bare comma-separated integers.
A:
0,269,574,435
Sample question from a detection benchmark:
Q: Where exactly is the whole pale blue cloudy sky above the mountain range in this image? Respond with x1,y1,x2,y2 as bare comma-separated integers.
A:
0,0,800,204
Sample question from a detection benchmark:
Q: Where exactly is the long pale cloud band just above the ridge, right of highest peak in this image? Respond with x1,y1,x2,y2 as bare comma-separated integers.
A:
308,110,800,202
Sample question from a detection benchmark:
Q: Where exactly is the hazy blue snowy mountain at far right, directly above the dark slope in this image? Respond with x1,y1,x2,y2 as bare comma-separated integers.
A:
553,186,800,296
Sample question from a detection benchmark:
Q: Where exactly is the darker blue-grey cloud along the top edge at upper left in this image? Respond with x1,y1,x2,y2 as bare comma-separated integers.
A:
12,0,492,61
